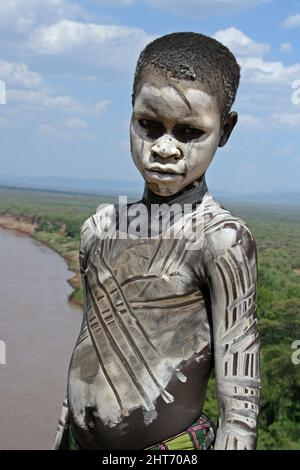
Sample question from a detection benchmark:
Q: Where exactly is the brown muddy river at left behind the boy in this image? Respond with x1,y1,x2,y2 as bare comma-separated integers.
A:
0,229,81,450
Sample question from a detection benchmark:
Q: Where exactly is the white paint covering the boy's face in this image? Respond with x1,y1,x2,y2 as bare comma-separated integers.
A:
130,84,221,196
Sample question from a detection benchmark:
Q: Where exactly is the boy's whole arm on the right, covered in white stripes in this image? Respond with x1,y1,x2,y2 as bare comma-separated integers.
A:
205,222,260,450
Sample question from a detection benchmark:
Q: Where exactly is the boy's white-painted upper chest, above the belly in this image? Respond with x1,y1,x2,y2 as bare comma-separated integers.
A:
88,235,202,309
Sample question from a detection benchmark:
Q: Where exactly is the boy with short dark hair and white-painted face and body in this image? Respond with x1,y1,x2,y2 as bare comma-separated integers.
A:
56,33,260,450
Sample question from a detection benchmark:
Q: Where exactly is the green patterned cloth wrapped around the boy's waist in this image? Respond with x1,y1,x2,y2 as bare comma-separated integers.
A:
69,413,215,450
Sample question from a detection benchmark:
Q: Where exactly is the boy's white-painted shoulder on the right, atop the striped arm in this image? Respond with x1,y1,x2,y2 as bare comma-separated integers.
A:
203,193,255,255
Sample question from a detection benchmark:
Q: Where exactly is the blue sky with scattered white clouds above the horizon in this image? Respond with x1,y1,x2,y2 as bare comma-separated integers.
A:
0,0,300,193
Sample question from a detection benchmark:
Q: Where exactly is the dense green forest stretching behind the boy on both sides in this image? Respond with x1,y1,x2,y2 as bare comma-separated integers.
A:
0,188,300,449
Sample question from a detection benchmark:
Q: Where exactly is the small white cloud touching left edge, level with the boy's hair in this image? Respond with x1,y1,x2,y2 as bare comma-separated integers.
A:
0,59,43,87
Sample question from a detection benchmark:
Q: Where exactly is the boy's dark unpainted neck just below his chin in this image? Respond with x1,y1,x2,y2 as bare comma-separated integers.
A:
142,175,207,205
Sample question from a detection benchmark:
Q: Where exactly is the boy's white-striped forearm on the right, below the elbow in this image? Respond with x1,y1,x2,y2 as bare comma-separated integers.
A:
215,284,260,450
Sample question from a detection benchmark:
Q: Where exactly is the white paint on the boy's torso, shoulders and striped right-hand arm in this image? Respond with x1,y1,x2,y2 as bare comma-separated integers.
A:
55,193,260,449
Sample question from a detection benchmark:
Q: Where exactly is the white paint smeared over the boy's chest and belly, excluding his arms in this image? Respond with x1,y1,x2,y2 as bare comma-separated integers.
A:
69,203,209,427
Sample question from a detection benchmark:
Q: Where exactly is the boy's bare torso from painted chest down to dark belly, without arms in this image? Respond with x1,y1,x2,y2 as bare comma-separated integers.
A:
68,194,241,449
